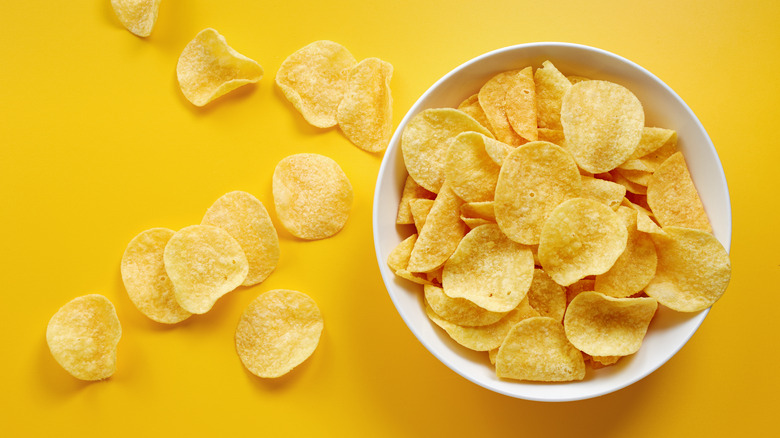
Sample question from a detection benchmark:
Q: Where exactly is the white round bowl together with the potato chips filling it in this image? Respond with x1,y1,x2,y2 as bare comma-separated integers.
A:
373,43,731,401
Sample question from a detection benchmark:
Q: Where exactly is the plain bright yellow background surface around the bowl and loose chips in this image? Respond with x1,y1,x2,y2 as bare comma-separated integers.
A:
0,0,780,437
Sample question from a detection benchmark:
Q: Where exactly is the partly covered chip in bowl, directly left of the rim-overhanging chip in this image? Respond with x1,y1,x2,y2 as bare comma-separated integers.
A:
594,207,658,298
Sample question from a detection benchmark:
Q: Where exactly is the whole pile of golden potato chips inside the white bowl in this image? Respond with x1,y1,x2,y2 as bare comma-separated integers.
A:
387,61,731,382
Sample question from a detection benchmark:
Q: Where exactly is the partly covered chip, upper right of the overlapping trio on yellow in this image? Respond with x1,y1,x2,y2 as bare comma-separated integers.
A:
201,191,279,286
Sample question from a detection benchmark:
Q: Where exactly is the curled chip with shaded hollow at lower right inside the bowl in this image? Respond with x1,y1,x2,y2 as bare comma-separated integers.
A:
563,292,658,356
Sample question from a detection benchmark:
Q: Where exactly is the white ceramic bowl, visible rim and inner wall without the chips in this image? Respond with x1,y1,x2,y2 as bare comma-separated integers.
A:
374,43,731,401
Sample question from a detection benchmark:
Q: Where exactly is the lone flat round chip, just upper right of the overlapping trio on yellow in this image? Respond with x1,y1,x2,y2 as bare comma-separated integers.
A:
273,154,353,240
